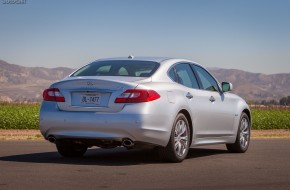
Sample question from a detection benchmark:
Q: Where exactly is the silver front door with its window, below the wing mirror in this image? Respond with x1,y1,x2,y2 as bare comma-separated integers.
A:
191,64,234,138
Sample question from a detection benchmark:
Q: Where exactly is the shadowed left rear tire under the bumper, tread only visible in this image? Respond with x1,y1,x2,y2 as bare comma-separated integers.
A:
56,140,88,157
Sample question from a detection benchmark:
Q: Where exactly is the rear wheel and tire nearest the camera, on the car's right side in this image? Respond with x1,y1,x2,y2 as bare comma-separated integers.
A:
158,113,190,162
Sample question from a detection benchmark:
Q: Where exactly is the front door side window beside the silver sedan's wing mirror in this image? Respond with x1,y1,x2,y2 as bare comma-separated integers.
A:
192,65,219,91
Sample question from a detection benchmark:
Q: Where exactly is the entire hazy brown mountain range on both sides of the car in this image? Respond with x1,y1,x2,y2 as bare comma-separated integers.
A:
0,60,290,102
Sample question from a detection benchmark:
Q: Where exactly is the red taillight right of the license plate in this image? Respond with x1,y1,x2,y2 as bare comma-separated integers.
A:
115,89,160,103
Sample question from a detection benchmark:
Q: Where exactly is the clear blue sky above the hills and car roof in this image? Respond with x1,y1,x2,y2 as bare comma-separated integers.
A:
0,0,290,74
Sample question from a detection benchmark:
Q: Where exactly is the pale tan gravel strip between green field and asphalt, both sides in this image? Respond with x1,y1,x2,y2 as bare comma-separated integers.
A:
0,129,290,140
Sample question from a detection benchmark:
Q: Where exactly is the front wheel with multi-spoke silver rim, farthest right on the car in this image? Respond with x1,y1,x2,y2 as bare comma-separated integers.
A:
226,112,251,153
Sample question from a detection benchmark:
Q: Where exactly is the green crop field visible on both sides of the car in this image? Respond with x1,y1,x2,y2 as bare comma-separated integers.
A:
0,103,290,129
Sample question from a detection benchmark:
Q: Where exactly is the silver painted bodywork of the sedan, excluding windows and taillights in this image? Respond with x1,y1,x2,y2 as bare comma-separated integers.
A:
39,57,250,148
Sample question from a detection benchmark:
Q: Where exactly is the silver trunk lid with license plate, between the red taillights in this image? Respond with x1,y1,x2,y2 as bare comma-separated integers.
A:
51,77,150,112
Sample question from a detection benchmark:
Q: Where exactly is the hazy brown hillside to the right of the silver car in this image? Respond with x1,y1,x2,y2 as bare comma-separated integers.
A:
209,68,290,101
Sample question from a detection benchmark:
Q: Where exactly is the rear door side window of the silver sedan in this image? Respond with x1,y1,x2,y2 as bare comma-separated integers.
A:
175,63,199,89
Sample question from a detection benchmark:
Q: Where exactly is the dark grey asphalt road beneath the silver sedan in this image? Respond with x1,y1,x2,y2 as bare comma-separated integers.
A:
0,139,290,190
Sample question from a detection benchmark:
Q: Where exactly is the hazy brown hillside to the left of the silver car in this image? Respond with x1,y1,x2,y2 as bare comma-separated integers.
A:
0,60,73,102
